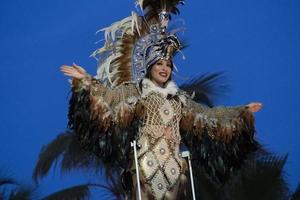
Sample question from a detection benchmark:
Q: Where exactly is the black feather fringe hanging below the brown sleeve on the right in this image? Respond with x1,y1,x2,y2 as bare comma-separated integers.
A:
183,130,259,185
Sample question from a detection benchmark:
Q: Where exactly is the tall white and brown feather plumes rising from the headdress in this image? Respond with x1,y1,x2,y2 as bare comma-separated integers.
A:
91,0,184,88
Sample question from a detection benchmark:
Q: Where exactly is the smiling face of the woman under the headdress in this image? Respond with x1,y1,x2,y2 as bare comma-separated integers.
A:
150,60,172,87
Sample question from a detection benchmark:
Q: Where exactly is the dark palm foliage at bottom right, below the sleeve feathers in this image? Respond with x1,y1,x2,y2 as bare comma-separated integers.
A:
189,155,290,200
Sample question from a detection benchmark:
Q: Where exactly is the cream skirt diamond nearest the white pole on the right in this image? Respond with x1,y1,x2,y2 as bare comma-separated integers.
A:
164,157,180,186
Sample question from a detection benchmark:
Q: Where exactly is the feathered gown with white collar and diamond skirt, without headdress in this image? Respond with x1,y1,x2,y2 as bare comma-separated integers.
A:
69,77,255,200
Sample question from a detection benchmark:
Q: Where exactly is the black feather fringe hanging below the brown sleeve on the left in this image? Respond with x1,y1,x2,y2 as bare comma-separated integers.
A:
66,91,138,192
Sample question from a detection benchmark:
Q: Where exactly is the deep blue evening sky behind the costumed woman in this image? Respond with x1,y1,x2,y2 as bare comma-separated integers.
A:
0,0,300,198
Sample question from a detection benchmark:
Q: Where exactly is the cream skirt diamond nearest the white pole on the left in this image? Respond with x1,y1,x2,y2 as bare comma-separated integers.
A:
139,151,159,180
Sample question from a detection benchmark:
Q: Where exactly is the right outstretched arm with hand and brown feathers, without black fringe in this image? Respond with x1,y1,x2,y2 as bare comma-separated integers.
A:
181,96,262,140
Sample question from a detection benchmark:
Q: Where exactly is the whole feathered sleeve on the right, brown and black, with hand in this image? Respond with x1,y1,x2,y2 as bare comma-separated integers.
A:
180,99,262,184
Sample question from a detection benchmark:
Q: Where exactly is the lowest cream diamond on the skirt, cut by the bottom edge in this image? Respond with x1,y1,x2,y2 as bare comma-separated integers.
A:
151,170,169,200
